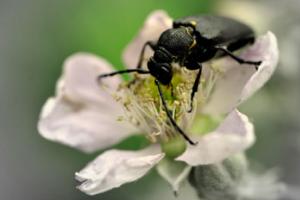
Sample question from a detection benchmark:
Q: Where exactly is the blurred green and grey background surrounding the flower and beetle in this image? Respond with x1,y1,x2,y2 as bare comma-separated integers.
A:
0,0,300,200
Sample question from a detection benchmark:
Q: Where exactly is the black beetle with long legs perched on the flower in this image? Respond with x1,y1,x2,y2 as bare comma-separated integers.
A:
98,15,261,145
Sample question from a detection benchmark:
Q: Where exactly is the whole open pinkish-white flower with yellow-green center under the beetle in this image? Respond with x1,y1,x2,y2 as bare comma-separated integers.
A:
38,11,278,195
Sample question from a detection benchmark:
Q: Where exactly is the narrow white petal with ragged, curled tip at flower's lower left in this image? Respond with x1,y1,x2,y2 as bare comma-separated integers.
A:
76,146,164,195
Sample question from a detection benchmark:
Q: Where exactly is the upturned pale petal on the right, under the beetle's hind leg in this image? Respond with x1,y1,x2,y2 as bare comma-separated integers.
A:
203,32,278,114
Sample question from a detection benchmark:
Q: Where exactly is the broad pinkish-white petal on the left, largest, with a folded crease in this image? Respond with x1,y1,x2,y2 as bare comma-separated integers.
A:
38,53,134,152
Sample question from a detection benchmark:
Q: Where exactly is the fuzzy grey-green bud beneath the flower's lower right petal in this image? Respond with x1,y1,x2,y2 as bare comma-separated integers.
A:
189,155,247,200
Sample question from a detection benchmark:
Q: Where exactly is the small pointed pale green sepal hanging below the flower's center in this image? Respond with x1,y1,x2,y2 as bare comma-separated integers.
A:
157,158,192,194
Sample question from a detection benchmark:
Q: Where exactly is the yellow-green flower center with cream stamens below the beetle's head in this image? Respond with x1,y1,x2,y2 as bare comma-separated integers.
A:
115,63,220,154
